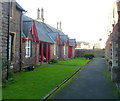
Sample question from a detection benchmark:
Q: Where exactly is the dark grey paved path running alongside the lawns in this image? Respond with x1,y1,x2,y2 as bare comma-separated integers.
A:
54,58,117,99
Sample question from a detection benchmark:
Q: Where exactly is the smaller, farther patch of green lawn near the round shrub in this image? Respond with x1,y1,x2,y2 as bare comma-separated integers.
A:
57,57,90,66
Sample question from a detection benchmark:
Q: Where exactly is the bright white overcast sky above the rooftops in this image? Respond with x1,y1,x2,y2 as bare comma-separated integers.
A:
17,0,113,42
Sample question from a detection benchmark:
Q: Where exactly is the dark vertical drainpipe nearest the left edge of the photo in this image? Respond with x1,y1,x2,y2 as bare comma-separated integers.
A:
6,0,11,80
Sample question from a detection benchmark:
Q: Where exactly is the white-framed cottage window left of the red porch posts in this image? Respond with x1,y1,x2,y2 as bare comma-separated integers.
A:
25,40,32,58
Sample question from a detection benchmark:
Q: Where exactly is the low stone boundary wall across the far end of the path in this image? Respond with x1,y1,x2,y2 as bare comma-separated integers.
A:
75,49,105,57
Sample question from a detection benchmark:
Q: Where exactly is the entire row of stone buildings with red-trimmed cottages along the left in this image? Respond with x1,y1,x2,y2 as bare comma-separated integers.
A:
0,2,76,78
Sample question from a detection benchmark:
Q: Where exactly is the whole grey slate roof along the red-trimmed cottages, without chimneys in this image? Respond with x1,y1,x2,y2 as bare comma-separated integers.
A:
23,15,75,46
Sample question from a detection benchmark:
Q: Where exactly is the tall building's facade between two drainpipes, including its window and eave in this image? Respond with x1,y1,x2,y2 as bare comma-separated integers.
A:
9,2,25,72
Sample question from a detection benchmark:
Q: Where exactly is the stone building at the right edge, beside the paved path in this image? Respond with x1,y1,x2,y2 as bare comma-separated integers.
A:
105,0,120,82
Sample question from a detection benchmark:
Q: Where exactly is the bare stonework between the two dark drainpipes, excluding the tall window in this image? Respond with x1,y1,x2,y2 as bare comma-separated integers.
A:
10,2,22,72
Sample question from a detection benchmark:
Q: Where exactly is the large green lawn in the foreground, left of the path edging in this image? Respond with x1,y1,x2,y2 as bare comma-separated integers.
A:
3,64,80,98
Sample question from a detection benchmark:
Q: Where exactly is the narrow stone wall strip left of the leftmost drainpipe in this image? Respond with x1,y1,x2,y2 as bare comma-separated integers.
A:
0,2,8,78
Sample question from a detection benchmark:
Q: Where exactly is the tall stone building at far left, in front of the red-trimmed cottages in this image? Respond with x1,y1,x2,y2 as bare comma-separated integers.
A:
0,1,25,78
